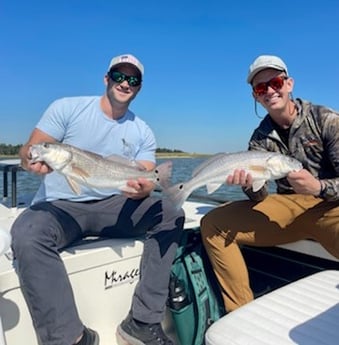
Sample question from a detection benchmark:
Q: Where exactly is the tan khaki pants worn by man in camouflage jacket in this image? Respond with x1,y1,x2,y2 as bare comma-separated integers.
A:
201,194,339,311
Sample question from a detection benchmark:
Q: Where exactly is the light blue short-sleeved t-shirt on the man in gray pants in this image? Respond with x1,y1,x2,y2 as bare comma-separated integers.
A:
33,96,156,203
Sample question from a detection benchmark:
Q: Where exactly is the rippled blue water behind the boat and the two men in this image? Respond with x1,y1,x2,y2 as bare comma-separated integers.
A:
0,158,274,201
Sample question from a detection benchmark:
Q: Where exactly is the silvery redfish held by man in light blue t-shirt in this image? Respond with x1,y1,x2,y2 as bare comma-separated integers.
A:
30,143,172,194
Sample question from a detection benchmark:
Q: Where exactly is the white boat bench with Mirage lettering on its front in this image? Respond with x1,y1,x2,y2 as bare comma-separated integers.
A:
0,202,213,345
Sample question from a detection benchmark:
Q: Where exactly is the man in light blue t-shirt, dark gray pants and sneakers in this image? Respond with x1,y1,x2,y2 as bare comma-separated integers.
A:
12,54,184,345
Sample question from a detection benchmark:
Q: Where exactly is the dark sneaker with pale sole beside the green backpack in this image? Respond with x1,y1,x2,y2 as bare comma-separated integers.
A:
116,313,174,345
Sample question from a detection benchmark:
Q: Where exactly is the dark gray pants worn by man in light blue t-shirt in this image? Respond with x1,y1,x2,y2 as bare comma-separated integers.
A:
12,195,184,345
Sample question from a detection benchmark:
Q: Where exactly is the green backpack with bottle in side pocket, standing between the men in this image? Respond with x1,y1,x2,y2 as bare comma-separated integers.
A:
168,229,225,345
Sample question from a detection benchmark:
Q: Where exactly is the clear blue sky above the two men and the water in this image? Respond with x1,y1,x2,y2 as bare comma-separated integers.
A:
0,0,339,153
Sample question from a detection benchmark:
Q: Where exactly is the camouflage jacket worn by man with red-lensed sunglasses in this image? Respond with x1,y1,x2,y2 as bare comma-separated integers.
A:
245,98,339,201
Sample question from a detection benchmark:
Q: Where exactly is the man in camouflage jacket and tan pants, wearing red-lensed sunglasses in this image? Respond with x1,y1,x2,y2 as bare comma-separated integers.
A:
201,55,339,311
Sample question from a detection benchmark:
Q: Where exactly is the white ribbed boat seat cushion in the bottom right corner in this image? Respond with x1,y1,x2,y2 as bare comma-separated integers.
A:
205,270,339,345
